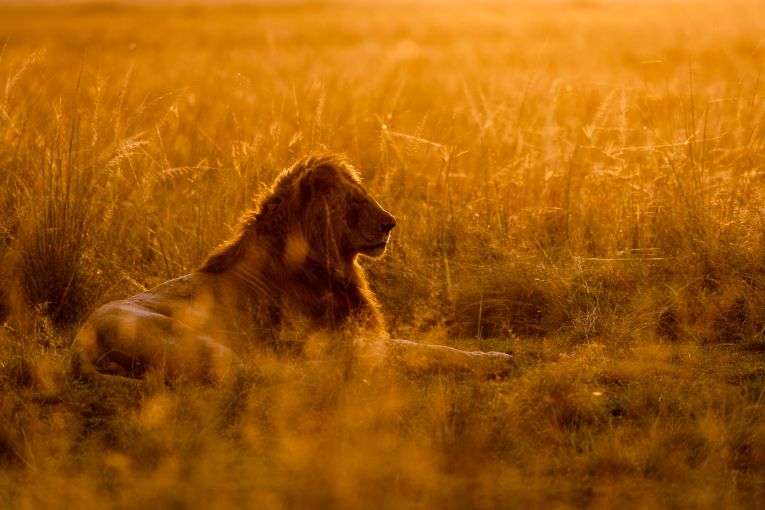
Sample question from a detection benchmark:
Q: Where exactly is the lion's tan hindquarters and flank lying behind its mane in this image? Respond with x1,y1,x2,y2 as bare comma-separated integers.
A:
74,272,260,380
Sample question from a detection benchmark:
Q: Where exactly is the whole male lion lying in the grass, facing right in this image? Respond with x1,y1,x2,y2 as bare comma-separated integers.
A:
72,154,509,382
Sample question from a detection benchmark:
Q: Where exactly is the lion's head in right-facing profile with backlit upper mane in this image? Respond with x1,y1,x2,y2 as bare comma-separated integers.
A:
202,153,396,272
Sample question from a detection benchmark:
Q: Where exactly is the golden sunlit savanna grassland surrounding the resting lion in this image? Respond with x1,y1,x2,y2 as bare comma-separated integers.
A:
0,0,765,509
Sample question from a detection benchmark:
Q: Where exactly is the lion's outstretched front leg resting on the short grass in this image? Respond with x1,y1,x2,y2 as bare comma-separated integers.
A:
388,338,513,373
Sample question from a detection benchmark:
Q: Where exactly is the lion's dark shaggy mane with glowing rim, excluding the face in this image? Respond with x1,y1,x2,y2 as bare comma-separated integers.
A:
198,153,384,331
